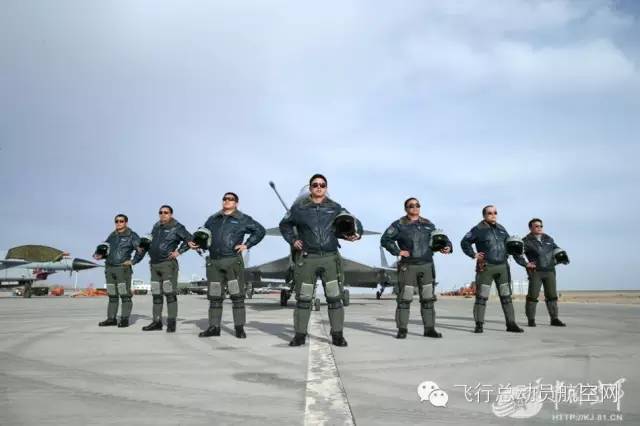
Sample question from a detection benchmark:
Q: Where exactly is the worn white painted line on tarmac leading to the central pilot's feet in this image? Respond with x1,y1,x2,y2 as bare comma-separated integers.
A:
304,312,355,426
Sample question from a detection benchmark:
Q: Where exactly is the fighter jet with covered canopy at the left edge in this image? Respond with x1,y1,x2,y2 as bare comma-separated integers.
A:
0,244,100,298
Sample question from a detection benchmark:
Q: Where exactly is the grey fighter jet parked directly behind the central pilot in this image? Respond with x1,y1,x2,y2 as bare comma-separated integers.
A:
245,182,398,310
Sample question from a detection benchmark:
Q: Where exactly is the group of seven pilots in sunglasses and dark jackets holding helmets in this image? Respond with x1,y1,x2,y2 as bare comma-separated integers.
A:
94,174,569,346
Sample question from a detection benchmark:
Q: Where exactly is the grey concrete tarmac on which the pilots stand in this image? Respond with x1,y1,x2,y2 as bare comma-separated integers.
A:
0,295,640,425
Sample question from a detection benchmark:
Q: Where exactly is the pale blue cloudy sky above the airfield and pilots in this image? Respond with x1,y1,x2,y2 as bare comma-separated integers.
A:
0,0,640,289
